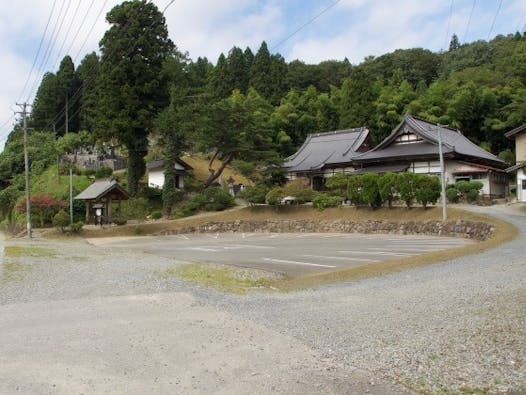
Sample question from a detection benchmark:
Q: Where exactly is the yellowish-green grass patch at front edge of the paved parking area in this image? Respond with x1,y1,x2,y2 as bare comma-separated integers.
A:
161,263,282,294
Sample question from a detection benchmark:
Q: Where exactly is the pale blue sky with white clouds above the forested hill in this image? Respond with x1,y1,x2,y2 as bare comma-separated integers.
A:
0,0,526,149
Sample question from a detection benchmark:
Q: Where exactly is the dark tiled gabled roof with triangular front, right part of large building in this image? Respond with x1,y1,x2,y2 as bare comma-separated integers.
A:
356,115,504,167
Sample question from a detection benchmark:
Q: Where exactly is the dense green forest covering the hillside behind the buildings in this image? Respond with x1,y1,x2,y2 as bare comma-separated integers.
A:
0,1,526,220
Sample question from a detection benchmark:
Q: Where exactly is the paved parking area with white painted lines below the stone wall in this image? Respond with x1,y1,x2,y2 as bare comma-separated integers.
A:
92,233,473,276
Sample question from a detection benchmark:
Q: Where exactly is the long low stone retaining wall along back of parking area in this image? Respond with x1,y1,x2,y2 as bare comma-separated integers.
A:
160,220,494,240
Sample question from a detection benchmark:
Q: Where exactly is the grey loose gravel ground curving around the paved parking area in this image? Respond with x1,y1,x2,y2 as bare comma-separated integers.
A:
0,207,526,393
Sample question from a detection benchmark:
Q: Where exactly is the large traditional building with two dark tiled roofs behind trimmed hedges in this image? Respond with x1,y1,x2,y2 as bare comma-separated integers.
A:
284,115,507,197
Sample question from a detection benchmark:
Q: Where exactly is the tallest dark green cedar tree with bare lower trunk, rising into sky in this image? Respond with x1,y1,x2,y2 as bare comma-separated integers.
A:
97,0,175,196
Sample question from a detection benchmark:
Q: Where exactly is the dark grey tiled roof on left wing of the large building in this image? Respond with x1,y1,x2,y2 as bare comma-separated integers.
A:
284,127,369,172
